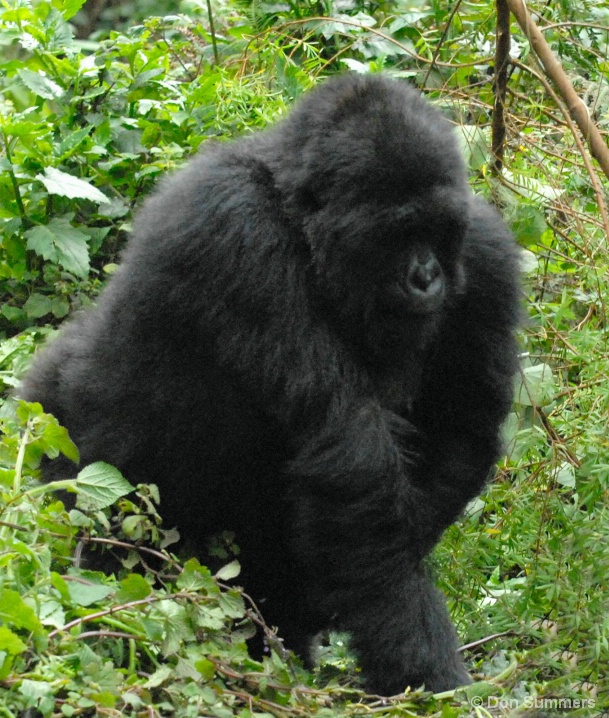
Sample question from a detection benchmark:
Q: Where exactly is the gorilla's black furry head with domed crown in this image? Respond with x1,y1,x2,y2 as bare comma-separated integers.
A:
276,75,471,340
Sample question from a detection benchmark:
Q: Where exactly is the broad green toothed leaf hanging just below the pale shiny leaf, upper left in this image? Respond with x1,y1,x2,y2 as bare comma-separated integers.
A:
25,217,89,277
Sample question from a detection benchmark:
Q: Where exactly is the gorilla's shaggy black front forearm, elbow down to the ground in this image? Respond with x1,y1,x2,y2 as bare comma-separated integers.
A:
290,405,470,695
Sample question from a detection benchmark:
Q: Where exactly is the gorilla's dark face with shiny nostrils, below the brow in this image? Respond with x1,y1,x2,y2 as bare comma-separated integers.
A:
306,186,469,323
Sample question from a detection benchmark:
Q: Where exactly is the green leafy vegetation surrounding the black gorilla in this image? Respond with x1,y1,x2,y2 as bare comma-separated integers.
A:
0,0,609,718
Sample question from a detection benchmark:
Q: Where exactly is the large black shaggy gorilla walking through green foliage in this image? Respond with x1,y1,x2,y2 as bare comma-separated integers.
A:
20,74,520,695
